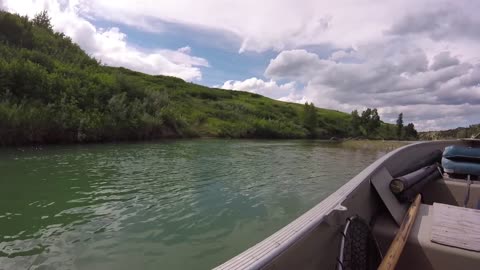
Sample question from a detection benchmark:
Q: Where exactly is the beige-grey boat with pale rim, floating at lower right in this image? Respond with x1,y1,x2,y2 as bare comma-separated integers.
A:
216,140,480,270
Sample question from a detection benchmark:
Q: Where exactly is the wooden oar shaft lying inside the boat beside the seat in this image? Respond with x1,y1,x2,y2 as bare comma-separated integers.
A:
378,194,422,270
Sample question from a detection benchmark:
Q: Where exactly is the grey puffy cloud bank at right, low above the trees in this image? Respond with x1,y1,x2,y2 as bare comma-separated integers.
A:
265,43,480,130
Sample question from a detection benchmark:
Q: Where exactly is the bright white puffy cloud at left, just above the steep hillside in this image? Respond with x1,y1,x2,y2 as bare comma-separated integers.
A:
6,0,209,80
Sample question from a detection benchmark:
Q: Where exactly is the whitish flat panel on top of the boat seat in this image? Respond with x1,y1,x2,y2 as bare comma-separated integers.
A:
431,203,480,251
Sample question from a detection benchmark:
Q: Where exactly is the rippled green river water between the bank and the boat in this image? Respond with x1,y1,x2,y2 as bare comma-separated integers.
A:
0,140,384,269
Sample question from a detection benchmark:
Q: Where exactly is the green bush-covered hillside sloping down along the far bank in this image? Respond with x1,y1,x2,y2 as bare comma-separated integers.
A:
0,11,417,146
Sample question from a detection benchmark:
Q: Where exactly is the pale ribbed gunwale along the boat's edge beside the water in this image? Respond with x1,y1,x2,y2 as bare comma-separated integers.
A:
214,140,459,270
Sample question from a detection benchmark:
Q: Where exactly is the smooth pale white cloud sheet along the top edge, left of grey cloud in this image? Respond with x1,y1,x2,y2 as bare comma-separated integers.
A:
57,0,420,52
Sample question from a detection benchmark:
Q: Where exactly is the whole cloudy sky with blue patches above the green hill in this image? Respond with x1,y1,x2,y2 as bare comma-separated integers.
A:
0,0,480,131
